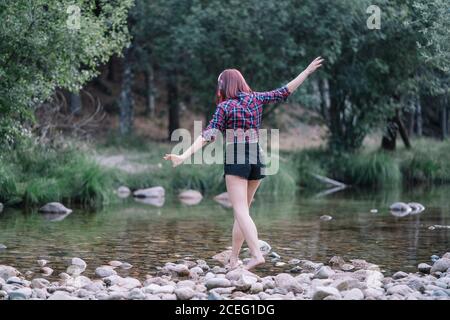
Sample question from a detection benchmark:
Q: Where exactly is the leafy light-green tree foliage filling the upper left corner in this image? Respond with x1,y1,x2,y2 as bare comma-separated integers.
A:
0,0,133,146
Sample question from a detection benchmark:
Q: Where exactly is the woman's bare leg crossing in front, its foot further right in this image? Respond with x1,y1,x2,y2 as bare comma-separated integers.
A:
225,175,264,269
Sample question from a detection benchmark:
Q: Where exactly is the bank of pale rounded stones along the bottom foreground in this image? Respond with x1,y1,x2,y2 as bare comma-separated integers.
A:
0,252,450,300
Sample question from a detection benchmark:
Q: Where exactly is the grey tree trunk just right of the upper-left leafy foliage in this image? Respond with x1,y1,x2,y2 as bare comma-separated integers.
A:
119,47,134,135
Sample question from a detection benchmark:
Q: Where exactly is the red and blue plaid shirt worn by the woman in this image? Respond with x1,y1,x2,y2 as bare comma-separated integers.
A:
202,86,290,142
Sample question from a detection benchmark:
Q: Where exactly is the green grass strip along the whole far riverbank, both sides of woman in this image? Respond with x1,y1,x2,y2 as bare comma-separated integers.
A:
0,137,450,207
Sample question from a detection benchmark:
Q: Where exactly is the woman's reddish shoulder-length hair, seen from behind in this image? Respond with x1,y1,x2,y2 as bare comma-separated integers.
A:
217,69,252,103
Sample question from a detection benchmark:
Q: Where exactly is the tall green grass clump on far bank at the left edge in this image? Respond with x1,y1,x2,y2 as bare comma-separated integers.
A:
0,142,114,206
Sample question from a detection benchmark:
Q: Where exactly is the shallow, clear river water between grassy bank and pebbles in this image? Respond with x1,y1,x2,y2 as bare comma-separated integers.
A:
0,187,450,278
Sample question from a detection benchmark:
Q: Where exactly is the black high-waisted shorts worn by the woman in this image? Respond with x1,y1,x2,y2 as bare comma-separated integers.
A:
224,143,265,180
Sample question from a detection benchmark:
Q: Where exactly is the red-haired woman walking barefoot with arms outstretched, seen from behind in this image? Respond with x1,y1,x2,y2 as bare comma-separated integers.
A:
164,57,324,270
